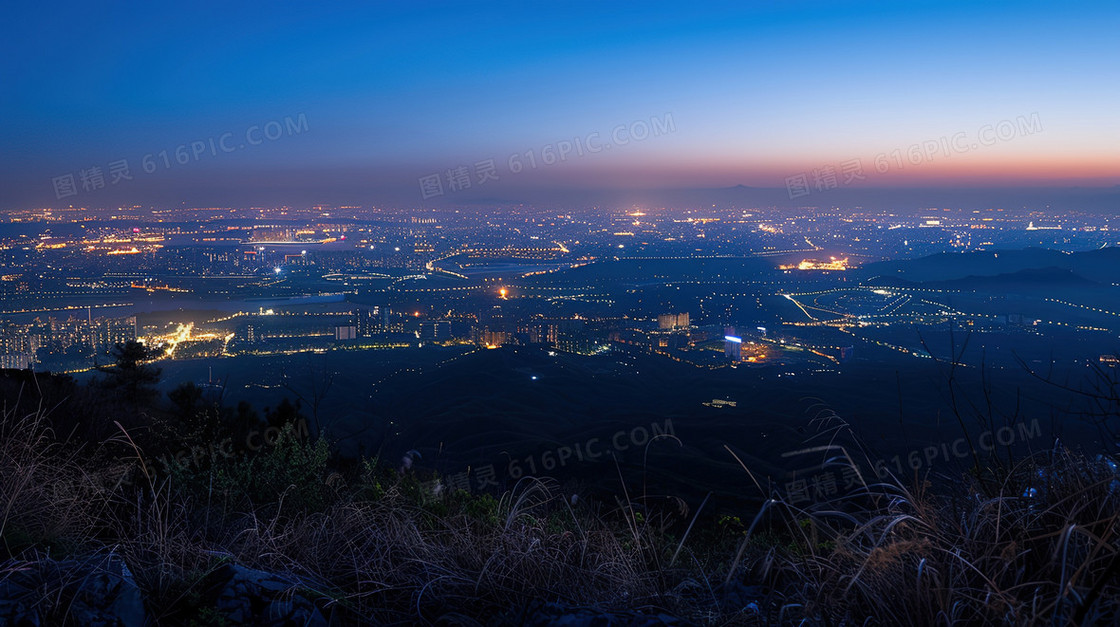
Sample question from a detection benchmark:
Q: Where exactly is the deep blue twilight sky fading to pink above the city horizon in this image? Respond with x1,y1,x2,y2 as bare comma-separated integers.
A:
0,1,1120,208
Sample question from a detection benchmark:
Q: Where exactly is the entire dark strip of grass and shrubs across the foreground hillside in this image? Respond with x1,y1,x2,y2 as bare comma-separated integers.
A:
0,373,1120,625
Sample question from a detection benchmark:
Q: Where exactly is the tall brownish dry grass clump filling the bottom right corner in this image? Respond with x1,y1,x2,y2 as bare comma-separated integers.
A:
725,438,1120,625
